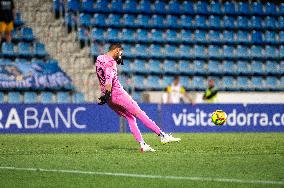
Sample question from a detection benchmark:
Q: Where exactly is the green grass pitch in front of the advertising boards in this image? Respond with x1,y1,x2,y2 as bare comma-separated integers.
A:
0,133,284,187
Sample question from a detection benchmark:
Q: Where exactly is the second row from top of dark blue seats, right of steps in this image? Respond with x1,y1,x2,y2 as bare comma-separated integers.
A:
77,13,284,30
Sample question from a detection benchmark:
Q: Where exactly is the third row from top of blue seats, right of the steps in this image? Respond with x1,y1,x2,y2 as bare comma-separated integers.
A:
83,28,284,44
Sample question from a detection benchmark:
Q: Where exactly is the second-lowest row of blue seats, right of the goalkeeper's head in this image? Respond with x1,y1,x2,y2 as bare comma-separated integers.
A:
119,59,284,75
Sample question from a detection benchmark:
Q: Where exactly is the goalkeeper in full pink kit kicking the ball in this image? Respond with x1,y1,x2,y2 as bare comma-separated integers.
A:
96,44,180,152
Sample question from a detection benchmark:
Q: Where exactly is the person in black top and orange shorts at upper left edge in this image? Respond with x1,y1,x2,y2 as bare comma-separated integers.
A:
0,0,16,43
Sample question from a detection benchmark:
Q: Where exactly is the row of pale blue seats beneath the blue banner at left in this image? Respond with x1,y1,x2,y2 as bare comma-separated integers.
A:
0,91,85,103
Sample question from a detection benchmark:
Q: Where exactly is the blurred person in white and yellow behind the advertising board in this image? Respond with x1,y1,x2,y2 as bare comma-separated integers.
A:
163,76,193,104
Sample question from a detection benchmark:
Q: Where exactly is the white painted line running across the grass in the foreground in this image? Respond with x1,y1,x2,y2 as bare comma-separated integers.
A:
0,166,284,185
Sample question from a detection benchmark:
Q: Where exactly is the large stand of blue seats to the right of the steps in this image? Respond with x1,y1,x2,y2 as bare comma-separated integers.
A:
52,0,284,101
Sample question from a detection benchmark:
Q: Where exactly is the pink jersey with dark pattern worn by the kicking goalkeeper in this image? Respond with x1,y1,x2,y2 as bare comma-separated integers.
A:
96,54,126,96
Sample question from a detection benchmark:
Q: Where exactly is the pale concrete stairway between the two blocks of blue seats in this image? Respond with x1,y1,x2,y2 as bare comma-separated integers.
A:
16,0,99,102
